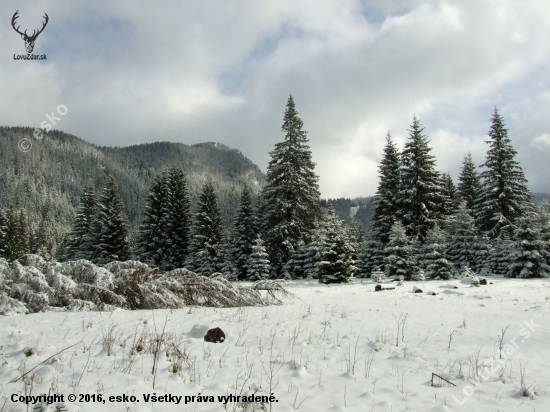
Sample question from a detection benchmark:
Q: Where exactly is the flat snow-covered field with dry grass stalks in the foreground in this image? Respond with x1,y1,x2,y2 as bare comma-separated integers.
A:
0,278,550,412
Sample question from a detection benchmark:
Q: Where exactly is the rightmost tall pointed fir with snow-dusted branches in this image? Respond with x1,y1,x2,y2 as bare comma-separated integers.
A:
474,108,534,239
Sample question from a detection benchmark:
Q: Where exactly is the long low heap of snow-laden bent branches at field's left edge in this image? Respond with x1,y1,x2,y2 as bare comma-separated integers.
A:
0,255,293,315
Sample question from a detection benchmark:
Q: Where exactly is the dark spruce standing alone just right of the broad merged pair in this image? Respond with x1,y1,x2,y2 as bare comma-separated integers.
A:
185,180,224,276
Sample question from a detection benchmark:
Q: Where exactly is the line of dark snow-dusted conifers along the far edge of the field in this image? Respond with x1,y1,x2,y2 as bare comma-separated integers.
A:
0,95,550,283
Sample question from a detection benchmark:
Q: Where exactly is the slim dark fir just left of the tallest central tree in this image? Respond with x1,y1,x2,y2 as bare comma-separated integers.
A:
230,187,263,280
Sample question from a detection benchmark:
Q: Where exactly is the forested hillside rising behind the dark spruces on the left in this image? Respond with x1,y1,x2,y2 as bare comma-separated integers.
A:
0,127,265,253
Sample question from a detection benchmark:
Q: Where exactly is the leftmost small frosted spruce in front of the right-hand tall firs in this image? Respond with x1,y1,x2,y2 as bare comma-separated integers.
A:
384,221,416,280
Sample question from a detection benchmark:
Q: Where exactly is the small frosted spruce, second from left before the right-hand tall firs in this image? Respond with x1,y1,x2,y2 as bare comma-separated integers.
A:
422,224,452,279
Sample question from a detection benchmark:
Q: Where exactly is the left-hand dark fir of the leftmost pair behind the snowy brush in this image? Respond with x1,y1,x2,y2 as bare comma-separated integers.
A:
59,183,97,260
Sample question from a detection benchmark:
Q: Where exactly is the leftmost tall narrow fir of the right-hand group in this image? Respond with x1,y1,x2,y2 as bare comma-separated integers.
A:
367,133,401,245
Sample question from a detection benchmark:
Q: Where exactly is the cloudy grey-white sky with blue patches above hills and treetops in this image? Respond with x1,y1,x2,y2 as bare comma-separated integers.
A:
0,0,550,197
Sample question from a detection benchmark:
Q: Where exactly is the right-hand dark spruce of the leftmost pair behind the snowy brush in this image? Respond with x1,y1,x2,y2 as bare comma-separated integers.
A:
92,176,130,264
